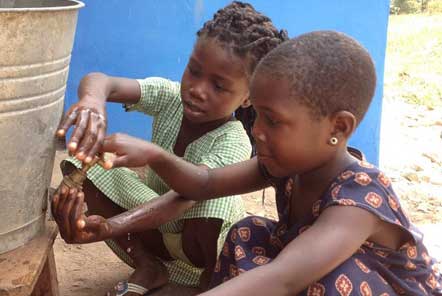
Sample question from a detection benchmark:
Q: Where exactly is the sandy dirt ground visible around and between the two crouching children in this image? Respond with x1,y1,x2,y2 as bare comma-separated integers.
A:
52,100,442,296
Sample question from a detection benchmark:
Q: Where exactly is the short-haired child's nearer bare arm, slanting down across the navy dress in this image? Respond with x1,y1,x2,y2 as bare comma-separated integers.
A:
202,206,381,296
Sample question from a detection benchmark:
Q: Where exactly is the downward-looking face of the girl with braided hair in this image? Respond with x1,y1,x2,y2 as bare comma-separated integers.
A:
181,38,249,123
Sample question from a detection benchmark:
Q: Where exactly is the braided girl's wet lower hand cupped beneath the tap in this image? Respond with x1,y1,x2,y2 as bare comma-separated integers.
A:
51,183,112,243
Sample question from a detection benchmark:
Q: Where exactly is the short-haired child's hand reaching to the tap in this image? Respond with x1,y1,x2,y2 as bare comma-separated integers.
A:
101,134,162,169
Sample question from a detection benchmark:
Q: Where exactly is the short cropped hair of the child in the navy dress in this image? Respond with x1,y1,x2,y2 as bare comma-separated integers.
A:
255,31,376,123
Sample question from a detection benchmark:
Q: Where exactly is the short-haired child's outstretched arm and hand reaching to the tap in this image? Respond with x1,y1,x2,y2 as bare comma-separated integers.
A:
102,134,269,200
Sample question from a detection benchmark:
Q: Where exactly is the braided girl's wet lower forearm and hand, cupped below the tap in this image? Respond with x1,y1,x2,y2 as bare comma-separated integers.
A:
51,185,195,243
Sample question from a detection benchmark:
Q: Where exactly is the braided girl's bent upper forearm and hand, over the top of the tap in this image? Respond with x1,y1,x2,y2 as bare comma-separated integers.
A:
57,73,141,162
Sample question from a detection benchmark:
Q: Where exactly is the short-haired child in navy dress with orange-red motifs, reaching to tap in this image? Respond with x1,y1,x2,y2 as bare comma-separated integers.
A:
77,31,440,296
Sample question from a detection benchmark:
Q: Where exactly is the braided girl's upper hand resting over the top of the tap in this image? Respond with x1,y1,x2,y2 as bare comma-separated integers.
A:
57,98,107,163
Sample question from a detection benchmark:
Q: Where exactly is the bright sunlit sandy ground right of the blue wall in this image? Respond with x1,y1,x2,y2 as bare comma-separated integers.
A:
380,99,442,224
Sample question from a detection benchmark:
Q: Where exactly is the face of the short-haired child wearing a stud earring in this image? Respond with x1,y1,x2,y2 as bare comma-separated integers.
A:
250,73,332,177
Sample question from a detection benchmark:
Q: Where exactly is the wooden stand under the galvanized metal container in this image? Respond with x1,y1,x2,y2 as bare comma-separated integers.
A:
0,222,58,296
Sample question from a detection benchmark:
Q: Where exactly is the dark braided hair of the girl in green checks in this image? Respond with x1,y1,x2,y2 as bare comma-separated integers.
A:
197,1,288,155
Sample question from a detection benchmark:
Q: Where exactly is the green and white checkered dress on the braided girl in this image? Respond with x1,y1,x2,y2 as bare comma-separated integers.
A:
69,77,251,286
